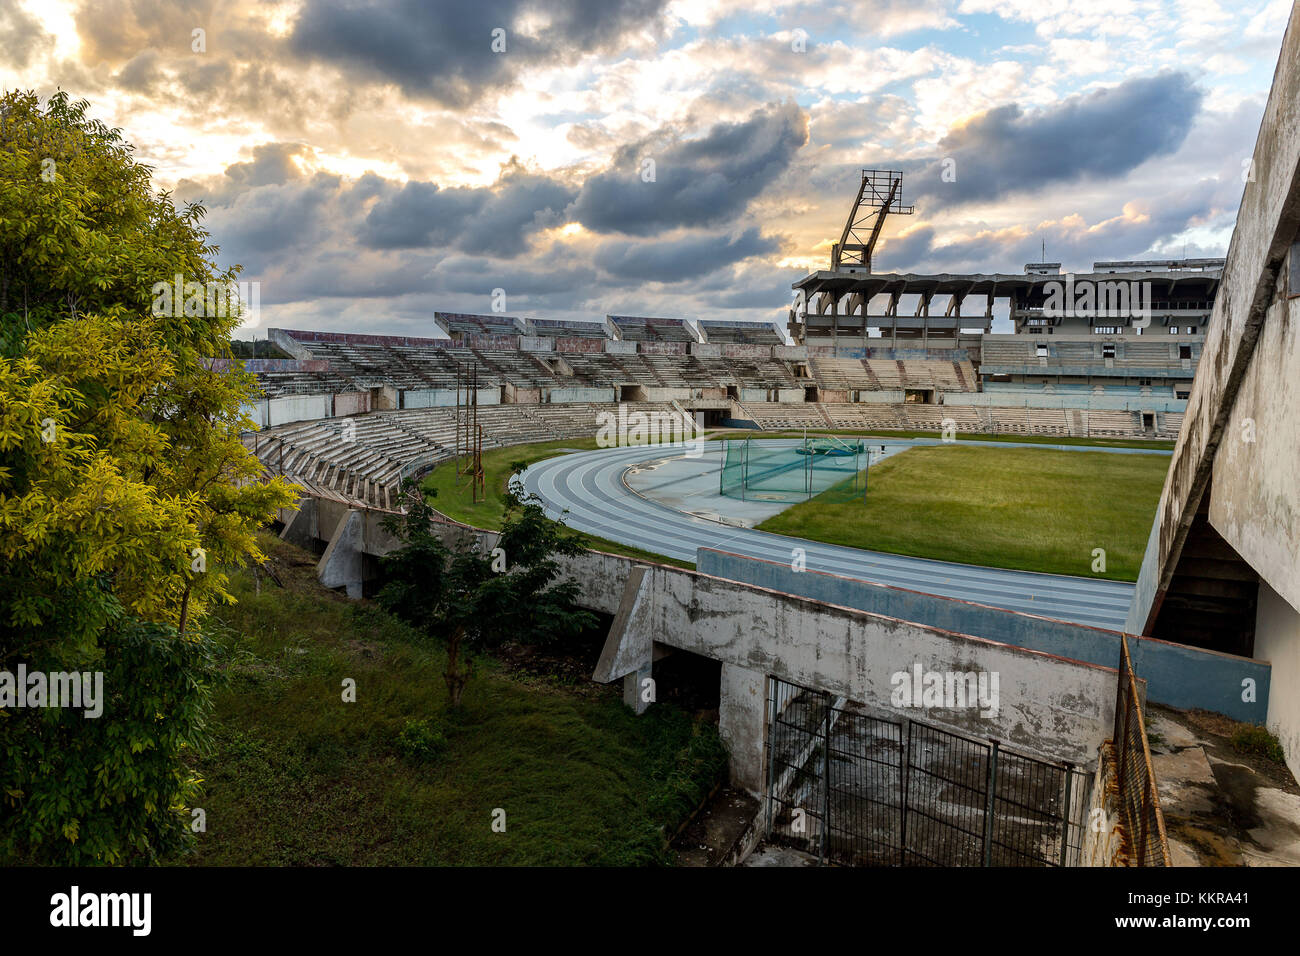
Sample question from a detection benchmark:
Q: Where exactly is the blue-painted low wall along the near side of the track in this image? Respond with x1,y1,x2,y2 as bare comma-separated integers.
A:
696,548,1274,726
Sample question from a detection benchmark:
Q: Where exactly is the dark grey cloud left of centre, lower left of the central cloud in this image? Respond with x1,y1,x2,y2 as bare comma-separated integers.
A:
360,173,573,258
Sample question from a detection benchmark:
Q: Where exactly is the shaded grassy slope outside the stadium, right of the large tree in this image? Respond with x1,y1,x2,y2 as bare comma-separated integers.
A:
192,538,724,865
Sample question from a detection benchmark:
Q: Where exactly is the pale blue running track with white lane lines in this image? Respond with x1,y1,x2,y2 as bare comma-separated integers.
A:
523,438,1169,630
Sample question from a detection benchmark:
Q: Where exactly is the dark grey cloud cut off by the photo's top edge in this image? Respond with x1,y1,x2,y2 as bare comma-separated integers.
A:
290,0,666,107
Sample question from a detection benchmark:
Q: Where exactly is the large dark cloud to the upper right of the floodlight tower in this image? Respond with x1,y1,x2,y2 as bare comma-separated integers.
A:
909,73,1203,213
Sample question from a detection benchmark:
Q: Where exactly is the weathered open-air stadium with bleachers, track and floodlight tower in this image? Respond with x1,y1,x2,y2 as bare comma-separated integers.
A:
231,35,1300,866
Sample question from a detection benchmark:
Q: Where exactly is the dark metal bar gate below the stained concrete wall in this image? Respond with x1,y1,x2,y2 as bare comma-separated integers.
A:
767,678,1092,866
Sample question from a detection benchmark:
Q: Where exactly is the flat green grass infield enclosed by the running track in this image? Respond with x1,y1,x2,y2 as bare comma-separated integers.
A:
758,445,1170,581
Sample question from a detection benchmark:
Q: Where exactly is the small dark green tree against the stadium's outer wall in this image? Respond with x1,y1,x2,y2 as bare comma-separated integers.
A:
378,490,595,708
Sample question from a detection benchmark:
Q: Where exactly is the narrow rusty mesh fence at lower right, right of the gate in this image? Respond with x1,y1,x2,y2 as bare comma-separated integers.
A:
1112,637,1171,866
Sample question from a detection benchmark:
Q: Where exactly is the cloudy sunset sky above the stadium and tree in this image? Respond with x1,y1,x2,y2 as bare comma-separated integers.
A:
0,0,1291,334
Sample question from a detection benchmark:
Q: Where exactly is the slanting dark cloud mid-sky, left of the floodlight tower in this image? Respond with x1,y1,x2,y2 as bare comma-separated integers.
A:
569,103,809,235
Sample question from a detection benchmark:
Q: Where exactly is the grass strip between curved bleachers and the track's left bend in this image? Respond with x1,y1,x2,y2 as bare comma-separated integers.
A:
421,437,694,568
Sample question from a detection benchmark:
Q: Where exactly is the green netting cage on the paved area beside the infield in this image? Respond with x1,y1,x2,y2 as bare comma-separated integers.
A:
718,438,866,501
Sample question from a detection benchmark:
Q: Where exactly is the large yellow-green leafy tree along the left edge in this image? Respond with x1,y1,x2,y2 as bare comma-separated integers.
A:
0,92,294,864
